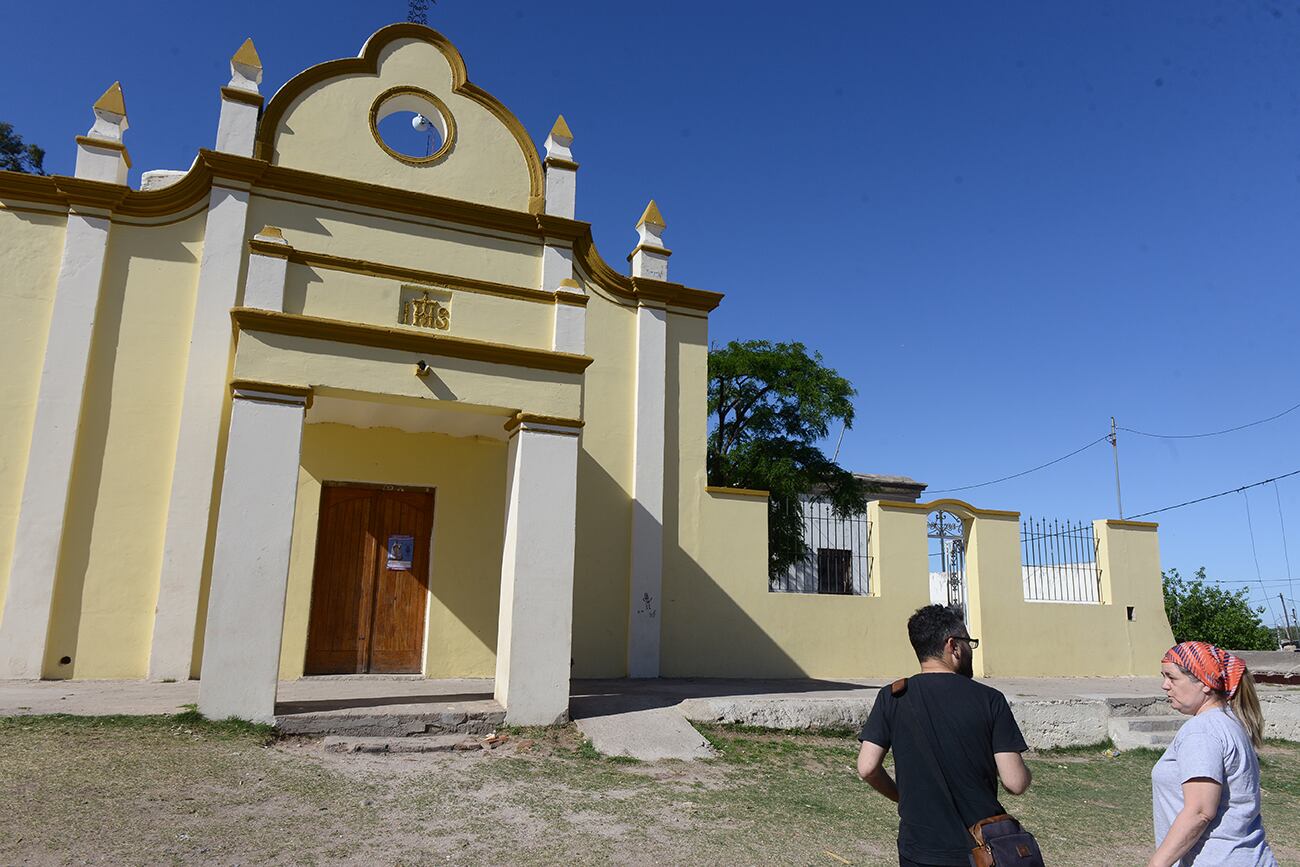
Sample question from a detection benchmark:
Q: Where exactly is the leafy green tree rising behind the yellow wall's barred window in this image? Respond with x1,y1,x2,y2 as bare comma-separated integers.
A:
709,341,870,578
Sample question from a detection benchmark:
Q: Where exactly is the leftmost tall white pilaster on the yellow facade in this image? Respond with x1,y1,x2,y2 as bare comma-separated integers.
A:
0,213,109,679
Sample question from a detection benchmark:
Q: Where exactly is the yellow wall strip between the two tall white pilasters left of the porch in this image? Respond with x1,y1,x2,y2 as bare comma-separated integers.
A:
44,213,204,679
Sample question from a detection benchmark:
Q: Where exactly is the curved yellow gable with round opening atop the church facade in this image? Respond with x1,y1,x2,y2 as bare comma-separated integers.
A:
257,23,543,213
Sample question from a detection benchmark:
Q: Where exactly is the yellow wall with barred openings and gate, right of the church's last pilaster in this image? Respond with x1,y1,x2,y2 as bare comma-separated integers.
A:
660,304,1173,679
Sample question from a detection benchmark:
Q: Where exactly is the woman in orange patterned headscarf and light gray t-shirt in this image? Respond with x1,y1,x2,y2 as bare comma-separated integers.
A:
1148,641,1278,867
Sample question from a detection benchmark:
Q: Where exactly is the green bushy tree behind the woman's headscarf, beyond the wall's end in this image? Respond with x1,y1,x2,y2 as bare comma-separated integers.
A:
1160,565,1278,650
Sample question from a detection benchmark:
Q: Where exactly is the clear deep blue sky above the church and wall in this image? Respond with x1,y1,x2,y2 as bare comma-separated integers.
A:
0,0,1300,619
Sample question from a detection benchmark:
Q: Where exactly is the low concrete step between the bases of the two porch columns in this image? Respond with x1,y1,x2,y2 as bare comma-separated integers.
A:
276,702,506,738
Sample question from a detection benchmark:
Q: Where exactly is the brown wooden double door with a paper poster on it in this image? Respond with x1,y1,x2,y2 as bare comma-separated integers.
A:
304,484,433,675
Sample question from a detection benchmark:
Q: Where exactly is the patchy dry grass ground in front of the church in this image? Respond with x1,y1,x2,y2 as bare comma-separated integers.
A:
0,715,1300,867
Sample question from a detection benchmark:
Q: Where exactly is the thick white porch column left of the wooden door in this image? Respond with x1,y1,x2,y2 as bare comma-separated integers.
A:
199,387,308,723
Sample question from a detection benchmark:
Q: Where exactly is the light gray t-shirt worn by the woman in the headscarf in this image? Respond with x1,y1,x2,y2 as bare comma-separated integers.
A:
1151,707,1278,867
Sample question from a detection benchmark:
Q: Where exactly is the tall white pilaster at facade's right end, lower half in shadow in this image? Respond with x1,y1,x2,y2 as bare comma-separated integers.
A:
628,303,668,677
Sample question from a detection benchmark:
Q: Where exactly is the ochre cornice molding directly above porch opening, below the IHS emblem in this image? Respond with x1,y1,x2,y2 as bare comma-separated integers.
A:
230,307,593,373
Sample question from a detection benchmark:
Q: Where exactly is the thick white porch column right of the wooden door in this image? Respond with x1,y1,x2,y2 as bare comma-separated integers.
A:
495,415,579,725
